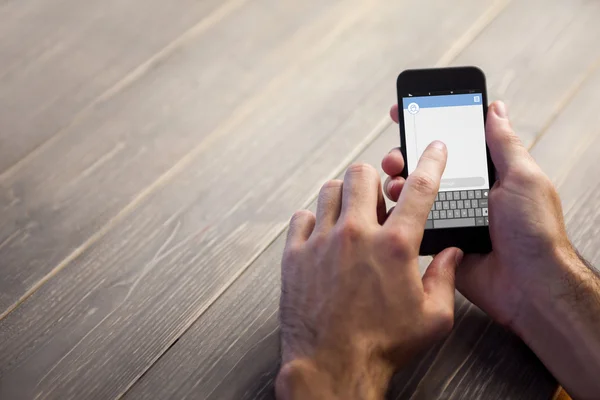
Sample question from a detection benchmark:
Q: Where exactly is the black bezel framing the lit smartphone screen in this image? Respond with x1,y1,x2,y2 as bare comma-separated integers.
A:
396,67,496,255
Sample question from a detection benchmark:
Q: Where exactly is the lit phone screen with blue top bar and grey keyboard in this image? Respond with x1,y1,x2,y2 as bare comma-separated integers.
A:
402,92,490,229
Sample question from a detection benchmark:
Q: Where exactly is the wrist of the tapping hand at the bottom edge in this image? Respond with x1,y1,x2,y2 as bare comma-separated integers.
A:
275,355,394,400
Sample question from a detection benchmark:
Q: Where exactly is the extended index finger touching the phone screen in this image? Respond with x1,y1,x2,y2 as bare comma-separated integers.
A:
386,140,448,242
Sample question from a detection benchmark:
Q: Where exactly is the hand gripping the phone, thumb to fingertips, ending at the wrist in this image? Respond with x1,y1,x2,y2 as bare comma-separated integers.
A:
382,102,574,326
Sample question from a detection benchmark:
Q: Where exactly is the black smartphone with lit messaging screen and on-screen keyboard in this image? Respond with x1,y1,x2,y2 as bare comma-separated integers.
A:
397,67,496,255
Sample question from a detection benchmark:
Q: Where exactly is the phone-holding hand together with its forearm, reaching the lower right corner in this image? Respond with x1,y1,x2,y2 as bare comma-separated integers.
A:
382,102,600,398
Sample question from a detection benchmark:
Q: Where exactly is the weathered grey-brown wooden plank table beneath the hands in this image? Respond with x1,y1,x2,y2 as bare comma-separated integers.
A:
0,0,600,399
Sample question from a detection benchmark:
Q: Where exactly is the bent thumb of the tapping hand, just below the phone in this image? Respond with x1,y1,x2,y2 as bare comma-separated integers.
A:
423,247,463,309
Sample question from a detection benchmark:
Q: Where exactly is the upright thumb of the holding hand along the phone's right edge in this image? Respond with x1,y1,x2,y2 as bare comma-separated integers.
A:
485,101,529,179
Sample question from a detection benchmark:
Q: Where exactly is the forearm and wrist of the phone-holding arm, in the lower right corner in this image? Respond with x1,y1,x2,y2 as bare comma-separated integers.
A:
513,251,600,399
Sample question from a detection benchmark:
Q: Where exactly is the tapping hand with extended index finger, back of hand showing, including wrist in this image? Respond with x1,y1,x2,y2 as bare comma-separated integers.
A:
276,142,462,399
